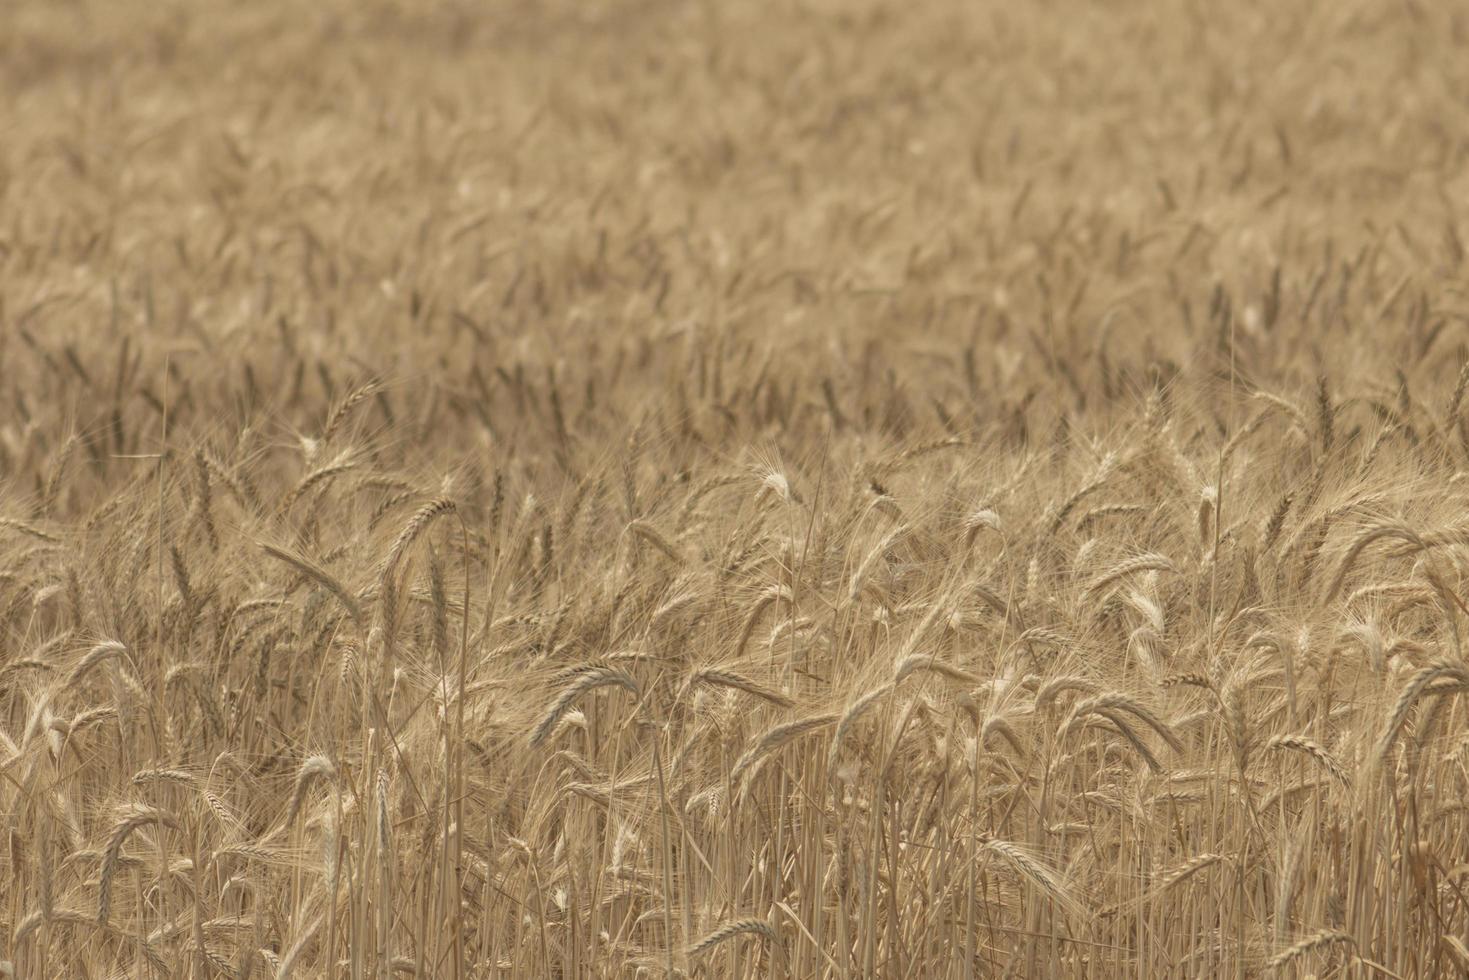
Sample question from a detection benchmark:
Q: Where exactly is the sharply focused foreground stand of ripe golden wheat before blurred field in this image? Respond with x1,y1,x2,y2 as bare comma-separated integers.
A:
14,348,1469,977
